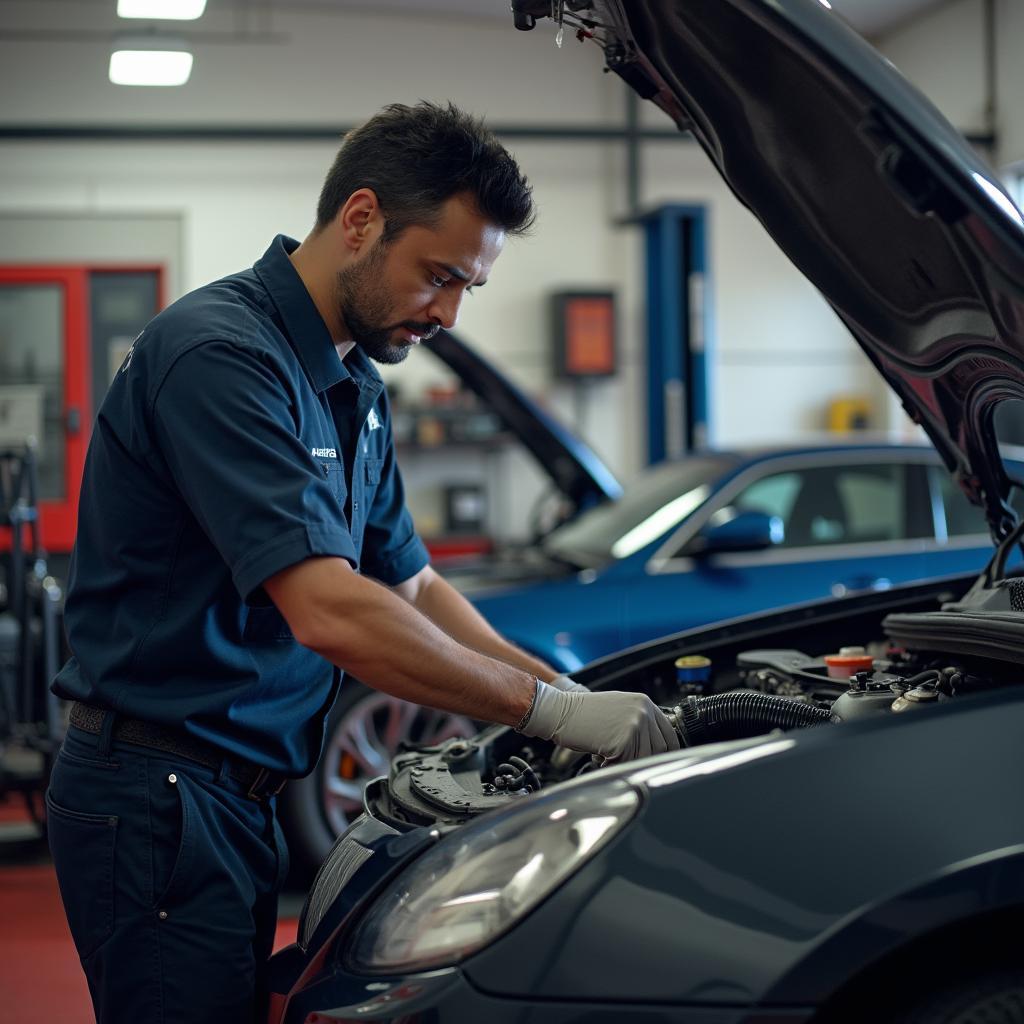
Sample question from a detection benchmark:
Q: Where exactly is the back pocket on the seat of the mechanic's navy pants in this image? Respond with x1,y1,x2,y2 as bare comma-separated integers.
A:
46,793,118,959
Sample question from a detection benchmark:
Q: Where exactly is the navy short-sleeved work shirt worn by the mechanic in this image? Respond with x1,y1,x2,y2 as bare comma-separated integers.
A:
53,236,428,775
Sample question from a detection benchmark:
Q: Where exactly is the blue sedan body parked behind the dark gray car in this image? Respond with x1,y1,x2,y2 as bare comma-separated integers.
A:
470,444,1024,672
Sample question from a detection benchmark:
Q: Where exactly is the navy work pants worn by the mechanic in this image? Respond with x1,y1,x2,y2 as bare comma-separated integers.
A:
46,715,288,1024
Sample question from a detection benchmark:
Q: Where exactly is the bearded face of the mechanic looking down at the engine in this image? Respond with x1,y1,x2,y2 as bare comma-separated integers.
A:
335,197,505,364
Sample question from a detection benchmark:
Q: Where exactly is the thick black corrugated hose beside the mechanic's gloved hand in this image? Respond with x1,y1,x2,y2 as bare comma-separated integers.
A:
670,692,831,746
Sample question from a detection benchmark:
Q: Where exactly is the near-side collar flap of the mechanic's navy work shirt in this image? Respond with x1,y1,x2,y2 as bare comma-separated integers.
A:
254,234,348,391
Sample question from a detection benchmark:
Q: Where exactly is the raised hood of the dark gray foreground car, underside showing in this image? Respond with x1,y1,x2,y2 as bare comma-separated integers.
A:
512,0,1024,539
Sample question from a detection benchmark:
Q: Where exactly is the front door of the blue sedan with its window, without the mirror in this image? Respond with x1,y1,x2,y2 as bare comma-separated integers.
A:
620,454,936,643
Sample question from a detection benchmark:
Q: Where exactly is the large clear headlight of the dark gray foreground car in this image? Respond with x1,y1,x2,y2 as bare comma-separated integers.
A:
350,780,640,971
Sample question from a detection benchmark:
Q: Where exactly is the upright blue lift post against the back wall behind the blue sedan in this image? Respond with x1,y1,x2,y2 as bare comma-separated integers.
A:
639,205,712,465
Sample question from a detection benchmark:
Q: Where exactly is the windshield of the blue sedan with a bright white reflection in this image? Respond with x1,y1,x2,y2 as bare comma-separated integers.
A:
543,456,736,568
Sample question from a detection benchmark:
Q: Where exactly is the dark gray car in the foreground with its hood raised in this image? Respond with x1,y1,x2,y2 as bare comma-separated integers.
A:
271,0,1024,1024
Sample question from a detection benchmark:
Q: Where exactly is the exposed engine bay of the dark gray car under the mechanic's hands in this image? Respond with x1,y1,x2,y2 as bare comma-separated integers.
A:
365,580,1024,831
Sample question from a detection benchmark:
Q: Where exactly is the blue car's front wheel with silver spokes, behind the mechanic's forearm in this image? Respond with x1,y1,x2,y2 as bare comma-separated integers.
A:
278,677,477,885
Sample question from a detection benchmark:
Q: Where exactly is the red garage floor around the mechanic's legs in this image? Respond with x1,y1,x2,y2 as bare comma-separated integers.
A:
0,803,297,1024
